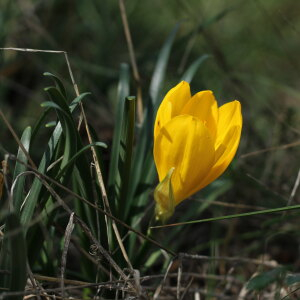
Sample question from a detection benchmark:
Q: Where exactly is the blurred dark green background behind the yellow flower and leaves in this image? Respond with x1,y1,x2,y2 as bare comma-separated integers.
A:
0,0,300,253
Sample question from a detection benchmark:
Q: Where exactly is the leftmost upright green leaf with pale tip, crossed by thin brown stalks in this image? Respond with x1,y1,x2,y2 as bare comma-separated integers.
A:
13,127,31,214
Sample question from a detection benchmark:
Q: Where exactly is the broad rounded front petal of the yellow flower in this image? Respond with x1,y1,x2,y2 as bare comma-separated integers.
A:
154,115,215,205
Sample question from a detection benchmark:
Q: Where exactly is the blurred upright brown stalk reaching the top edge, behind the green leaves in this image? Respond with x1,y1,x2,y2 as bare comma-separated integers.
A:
119,0,143,124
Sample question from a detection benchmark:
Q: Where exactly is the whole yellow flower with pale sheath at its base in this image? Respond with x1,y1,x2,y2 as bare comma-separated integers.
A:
153,81,242,221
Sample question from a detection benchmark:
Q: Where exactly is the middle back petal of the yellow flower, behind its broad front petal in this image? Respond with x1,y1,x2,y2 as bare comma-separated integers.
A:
182,91,219,139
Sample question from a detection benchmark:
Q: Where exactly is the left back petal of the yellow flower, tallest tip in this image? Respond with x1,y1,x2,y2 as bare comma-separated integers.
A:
154,81,191,138
